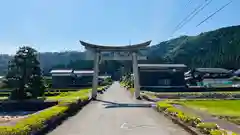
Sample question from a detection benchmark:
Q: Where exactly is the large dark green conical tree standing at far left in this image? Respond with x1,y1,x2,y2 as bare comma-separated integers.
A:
6,46,44,100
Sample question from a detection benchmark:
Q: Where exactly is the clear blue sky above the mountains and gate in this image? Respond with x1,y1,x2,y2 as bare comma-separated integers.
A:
0,0,240,54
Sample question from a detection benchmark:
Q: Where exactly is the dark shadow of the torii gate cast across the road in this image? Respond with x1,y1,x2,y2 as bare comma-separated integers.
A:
95,99,153,108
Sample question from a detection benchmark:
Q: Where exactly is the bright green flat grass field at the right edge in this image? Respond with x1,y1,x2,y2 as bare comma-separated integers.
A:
180,100,240,116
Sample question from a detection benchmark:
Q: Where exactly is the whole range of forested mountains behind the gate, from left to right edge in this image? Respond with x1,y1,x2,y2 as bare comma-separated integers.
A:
0,26,240,74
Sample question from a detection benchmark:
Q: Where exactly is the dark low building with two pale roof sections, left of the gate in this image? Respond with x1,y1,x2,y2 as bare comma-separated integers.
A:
50,69,94,88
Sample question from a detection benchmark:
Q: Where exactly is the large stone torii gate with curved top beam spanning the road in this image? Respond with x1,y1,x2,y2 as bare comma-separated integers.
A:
80,41,151,99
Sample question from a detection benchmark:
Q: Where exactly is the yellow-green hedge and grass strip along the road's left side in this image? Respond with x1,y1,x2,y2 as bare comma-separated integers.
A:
0,89,91,135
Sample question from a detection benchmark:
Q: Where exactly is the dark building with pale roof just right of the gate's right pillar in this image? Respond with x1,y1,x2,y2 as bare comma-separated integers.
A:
138,64,187,88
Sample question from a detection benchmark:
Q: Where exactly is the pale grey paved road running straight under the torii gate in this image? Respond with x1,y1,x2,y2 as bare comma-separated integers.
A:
49,82,189,135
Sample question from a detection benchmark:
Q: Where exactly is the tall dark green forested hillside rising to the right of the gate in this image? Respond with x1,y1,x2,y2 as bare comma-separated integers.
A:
146,26,240,69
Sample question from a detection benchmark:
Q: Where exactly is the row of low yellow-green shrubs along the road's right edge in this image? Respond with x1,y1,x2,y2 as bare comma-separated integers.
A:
157,101,237,135
